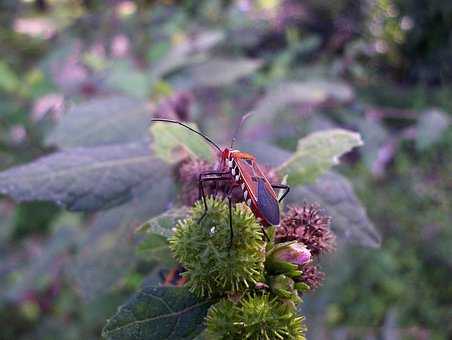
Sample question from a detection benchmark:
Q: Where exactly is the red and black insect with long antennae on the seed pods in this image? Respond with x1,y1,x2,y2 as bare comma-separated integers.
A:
152,114,290,248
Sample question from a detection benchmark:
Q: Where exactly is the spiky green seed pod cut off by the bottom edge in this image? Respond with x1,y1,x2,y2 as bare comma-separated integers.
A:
206,294,305,340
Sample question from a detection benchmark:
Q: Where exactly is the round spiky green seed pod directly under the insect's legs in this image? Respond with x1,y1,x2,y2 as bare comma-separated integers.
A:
169,198,265,297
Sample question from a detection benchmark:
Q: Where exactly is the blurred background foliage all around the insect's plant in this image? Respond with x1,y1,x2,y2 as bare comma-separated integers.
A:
0,0,452,339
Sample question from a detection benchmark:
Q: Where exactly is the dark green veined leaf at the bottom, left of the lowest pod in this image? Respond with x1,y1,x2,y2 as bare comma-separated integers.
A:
102,287,211,340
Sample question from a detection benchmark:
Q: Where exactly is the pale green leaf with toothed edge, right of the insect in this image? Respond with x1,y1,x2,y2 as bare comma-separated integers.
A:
277,129,363,185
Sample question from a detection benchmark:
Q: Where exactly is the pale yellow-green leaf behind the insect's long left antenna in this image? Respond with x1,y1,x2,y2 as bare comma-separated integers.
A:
150,122,213,163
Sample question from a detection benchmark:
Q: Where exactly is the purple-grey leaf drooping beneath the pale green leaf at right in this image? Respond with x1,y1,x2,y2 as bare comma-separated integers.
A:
287,172,381,248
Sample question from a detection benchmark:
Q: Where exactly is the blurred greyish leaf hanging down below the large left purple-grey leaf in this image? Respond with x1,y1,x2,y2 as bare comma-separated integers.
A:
69,177,174,301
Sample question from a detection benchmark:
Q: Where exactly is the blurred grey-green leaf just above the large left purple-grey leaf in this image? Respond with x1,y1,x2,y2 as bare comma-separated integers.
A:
46,96,151,149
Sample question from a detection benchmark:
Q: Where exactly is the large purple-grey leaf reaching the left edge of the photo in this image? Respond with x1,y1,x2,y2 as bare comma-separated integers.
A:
0,143,168,211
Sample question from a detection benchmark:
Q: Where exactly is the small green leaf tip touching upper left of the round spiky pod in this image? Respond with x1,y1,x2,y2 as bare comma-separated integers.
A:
137,207,190,237
